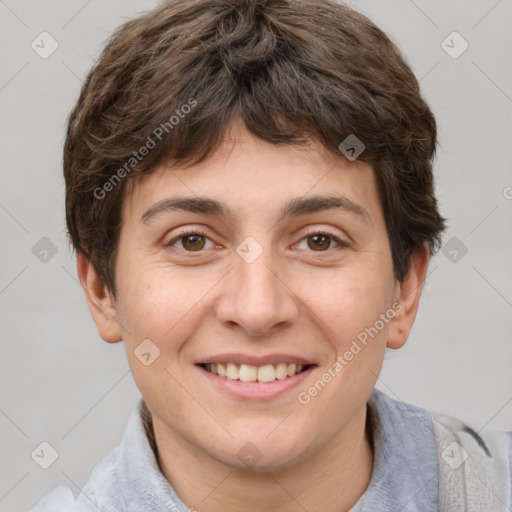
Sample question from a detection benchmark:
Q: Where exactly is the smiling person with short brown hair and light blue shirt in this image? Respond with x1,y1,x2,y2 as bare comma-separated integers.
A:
32,0,512,512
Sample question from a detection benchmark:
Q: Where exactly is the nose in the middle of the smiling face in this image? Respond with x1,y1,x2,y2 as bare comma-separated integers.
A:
216,241,300,337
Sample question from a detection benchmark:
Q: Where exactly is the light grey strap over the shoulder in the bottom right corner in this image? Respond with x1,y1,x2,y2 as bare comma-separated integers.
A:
432,413,512,512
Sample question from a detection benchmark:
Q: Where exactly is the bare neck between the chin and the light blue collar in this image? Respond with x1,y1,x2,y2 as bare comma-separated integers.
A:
153,404,373,512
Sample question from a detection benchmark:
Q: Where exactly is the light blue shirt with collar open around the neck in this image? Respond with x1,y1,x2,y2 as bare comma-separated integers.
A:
29,389,512,512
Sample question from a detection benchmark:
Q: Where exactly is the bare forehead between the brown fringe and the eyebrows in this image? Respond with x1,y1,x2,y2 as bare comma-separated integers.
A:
123,124,380,230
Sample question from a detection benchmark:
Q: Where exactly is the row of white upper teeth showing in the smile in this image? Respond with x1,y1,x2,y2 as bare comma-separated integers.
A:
206,363,304,382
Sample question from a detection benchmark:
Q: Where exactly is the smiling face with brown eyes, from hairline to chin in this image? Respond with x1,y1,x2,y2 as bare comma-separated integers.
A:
82,122,426,469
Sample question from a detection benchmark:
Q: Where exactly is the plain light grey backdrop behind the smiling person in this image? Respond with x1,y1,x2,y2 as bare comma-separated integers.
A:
0,0,512,512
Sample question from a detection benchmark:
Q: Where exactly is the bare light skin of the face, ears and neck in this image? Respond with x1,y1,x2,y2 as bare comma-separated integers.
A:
78,121,429,512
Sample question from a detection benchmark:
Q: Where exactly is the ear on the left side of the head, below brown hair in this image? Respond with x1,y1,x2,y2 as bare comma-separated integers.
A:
76,253,123,343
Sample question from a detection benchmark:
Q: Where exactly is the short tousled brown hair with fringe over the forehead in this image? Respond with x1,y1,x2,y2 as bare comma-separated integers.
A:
64,0,446,294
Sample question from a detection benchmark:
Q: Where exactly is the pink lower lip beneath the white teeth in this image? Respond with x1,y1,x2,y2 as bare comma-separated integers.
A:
197,365,316,399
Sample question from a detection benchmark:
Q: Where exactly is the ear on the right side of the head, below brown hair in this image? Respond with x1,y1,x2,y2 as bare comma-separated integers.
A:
387,244,430,349
